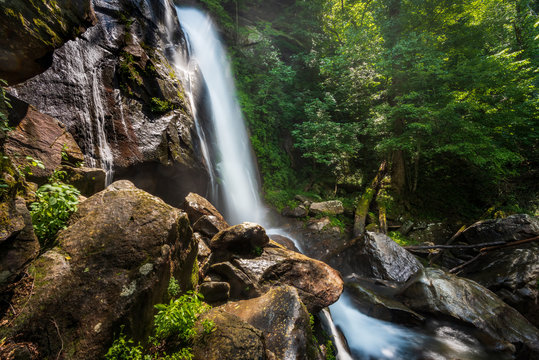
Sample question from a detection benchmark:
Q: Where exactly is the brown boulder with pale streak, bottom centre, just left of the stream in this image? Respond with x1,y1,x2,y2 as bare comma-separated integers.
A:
221,286,314,359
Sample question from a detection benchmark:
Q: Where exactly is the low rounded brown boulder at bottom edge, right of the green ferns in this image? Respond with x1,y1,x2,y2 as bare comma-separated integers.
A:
193,308,267,360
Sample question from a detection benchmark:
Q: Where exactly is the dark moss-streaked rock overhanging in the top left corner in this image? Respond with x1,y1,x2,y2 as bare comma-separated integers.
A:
0,0,96,83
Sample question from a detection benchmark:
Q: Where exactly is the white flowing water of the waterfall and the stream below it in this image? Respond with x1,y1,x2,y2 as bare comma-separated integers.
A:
176,8,494,360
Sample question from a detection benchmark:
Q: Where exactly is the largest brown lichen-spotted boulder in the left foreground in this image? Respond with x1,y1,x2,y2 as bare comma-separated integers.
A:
0,181,197,359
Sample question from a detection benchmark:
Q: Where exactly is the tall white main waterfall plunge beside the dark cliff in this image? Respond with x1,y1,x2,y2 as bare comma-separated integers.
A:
177,8,265,224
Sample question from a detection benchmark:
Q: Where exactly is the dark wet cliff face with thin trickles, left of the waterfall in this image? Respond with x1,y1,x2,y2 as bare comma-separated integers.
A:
10,0,208,204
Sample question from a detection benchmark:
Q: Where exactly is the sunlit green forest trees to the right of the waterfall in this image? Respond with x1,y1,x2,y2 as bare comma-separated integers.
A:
202,0,539,217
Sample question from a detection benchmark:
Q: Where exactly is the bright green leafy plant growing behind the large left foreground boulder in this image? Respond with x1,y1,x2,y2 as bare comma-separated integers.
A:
30,176,80,247
